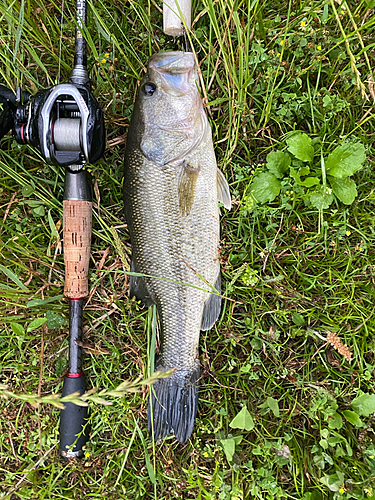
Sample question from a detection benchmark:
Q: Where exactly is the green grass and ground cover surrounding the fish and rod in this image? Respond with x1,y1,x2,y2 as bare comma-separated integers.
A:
0,0,375,500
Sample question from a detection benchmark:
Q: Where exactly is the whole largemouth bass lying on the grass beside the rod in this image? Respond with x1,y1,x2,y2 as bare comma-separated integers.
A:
124,52,231,443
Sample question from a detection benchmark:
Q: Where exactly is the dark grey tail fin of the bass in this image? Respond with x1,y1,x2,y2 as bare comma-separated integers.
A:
148,365,200,443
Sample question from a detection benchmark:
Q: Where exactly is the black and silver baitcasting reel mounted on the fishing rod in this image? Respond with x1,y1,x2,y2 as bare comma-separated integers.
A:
0,75,105,167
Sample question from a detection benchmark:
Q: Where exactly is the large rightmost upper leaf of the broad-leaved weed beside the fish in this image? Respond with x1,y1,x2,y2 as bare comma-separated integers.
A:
325,142,366,179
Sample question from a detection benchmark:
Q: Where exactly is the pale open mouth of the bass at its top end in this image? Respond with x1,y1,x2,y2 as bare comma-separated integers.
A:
148,52,196,96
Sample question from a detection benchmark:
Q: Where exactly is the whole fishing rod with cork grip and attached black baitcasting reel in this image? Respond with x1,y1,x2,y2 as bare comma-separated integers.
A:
0,0,106,459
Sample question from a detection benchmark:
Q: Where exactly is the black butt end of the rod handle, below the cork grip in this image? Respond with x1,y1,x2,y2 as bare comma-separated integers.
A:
60,373,88,459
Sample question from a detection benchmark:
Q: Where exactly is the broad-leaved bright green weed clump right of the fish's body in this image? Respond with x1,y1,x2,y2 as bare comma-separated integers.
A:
244,132,366,231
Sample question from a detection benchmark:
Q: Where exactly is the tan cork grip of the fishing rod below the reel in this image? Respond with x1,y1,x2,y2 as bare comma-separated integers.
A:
64,200,92,299
